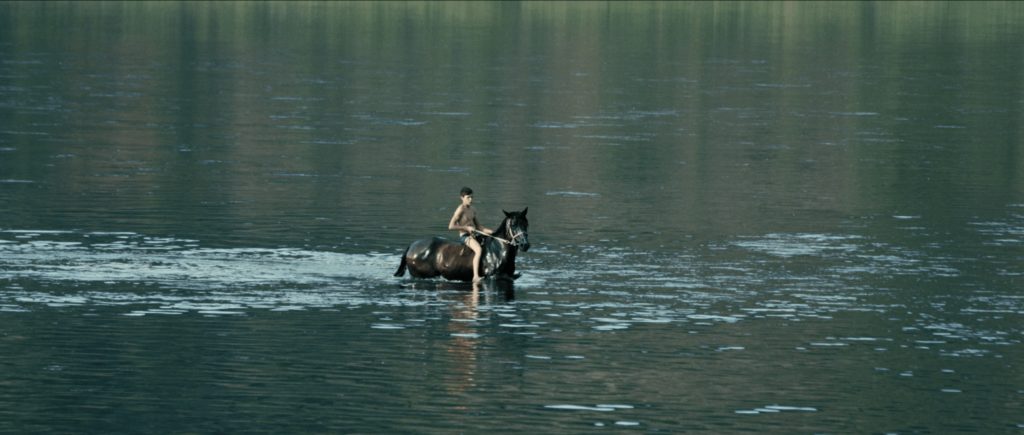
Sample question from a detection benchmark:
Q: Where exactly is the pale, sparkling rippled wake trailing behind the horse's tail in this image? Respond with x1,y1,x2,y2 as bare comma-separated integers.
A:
0,230,405,315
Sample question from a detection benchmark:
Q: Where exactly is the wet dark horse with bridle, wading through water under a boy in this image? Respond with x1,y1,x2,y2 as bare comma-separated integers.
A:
394,208,529,281
